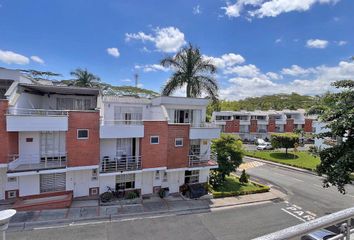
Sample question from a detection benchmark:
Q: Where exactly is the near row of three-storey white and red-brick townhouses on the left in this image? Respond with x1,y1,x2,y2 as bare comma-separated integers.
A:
0,69,220,200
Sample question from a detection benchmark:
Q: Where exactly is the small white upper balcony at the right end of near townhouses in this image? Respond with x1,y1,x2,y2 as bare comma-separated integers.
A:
189,123,221,139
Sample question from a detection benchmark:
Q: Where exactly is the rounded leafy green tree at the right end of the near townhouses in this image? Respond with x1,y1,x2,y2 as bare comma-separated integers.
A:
211,134,243,186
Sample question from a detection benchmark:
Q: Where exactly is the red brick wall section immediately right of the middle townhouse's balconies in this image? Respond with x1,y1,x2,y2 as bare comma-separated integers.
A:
141,121,168,168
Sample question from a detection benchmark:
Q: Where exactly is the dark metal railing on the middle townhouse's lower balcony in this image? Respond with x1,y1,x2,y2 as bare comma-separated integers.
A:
100,156,141,173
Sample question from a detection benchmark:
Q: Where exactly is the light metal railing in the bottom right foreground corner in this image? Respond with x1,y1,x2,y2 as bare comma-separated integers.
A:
253,207,354,240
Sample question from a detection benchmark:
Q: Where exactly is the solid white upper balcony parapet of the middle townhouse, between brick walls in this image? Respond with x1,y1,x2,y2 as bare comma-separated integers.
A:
100,120,144,138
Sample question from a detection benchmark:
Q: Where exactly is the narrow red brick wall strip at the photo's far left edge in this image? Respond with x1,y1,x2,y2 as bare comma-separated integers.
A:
0,100,18,163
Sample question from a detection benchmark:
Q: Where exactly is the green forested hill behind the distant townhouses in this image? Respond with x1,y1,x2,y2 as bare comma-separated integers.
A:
208,93,316,111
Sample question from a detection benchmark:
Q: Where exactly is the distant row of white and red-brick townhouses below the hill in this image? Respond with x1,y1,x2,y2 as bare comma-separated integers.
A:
212,109,315,141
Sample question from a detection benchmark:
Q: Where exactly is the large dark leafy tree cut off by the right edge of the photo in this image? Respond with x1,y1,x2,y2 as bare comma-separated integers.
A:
312,80,354,194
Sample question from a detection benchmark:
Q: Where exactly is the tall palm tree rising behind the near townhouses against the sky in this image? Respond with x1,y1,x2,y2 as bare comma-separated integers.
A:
161,44,219,101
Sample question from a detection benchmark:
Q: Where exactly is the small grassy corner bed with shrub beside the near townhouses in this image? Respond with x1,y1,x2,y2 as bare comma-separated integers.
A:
211,175,269,198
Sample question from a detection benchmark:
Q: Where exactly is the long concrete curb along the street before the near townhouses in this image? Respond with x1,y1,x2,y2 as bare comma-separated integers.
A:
9,193,282,232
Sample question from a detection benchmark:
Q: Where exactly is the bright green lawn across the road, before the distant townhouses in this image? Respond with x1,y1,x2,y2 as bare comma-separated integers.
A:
246,151,320,171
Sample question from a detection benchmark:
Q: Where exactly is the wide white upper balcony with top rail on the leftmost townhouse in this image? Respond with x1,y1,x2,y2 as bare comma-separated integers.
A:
6,108,68,132
